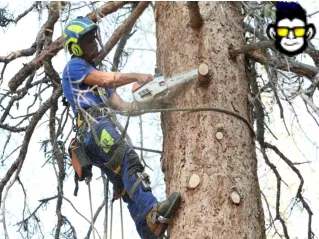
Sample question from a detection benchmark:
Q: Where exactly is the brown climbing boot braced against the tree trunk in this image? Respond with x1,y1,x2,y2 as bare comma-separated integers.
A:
146,192,181,238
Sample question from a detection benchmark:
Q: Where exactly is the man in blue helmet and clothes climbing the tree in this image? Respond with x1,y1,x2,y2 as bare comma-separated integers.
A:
62,17,181,239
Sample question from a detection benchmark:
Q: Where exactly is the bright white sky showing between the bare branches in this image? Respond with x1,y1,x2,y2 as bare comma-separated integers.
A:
0,1,319,239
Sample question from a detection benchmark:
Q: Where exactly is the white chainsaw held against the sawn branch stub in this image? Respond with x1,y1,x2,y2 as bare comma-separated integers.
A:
132,68,198,109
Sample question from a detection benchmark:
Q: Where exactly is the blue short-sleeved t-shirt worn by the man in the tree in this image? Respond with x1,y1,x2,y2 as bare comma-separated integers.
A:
62,57,115,115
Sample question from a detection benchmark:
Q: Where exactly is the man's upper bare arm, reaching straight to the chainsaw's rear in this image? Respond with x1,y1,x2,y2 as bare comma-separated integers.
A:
83,70,153,88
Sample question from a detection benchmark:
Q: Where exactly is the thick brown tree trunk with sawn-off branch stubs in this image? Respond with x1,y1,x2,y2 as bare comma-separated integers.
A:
155,2,265,239
